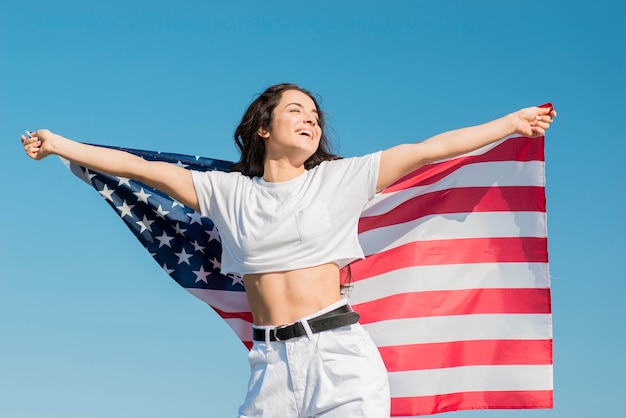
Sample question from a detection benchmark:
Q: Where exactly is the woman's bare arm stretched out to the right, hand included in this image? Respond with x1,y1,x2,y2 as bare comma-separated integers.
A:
377,107,556,191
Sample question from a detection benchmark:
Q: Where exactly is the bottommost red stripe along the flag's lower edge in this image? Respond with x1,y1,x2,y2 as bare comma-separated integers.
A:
391,390,554,416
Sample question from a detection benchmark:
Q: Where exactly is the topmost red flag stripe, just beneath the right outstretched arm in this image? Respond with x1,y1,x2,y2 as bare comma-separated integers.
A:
384,137,544,193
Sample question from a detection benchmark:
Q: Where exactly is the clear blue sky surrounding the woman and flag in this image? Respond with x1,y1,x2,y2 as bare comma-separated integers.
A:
0,0,626,418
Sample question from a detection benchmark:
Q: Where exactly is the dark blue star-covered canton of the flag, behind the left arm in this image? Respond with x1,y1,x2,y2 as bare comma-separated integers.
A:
65,147,244,293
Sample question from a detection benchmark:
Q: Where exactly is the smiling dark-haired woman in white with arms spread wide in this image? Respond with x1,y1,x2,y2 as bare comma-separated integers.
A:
22,84,556,418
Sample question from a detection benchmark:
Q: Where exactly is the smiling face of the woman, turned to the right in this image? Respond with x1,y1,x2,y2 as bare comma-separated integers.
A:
259,90,322,165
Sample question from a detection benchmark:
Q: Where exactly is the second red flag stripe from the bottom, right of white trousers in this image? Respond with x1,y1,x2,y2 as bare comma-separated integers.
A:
378,340,552,372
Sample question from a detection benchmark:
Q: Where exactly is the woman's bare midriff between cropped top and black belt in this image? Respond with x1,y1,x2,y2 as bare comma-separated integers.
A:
243,263,341,325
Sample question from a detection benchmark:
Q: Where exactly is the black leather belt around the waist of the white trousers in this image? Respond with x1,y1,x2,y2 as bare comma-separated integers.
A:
252,305,360,341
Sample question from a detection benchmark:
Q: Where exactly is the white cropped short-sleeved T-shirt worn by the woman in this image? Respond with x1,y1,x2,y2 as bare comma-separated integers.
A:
192,152,381,274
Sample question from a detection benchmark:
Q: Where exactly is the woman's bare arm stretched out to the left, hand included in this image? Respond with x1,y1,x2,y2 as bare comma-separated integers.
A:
22,129,199,210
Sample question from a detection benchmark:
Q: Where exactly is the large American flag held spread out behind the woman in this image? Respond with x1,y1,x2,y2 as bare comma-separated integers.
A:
65,137,553,416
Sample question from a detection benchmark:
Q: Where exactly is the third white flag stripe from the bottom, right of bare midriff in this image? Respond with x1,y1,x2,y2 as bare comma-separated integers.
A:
347,263,549,304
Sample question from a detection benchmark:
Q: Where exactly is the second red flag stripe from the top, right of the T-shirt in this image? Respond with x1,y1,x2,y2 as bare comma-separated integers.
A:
359,186,546,233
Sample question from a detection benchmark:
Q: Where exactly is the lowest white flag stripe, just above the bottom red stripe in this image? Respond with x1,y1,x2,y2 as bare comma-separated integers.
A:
389,365,553,397
